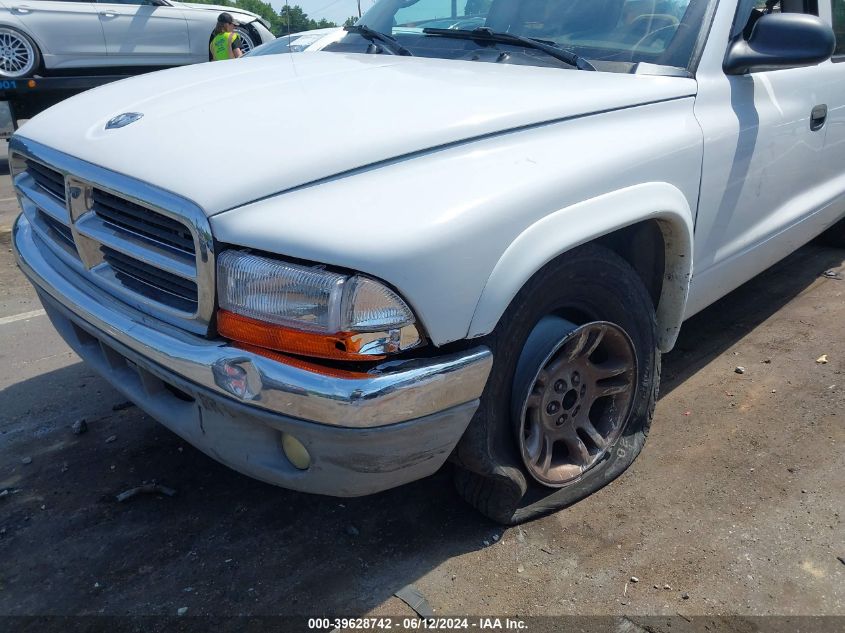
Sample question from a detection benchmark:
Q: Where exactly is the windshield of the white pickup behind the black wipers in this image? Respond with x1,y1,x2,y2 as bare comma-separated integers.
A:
327,0,713,72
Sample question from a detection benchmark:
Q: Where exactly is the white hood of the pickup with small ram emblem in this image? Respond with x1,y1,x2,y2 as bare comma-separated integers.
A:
18,52,696,215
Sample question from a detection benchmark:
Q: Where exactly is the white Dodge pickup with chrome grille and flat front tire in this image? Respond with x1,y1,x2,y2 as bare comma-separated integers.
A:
10,0,845,523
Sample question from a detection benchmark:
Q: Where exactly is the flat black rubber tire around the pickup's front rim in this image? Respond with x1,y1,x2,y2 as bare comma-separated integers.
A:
459,245,660,521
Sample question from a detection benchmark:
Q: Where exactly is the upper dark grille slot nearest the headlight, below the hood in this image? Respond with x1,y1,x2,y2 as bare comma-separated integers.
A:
93,188,196,256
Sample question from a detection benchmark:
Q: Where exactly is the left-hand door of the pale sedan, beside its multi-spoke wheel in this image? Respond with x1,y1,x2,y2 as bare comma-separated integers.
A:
3,0,106,58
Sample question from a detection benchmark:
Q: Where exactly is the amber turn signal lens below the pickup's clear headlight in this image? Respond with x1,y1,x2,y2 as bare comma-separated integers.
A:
217,310,384,361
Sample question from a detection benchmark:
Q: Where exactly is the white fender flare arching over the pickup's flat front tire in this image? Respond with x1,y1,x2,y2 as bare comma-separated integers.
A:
467,182,694,352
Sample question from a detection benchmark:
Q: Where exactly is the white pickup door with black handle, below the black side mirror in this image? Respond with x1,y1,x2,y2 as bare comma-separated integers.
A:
688,0,845,316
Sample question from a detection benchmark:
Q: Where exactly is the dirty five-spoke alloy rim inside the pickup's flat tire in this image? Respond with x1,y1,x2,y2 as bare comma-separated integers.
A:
519,321,637,488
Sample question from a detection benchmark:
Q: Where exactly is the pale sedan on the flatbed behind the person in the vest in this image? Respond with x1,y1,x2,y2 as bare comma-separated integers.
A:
0,0,274,79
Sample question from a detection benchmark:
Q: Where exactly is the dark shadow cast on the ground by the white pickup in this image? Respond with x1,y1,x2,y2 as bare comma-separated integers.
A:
0,239,845,616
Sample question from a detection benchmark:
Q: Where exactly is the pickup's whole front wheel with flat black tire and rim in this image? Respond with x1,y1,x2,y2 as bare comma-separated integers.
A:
454,245,660,524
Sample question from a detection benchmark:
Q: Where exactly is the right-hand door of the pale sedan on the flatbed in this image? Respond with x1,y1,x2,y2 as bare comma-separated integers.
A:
97,0,191,66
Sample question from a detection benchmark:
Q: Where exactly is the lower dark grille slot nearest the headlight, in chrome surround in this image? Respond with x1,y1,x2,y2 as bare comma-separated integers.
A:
100,246,198,312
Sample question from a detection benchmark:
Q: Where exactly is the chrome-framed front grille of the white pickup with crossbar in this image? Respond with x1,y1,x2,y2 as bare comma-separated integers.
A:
10,138,214,334
